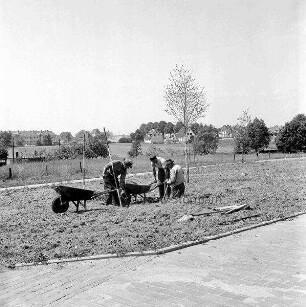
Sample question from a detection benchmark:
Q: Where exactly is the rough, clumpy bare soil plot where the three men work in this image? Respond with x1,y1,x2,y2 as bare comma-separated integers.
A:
0,158,306,265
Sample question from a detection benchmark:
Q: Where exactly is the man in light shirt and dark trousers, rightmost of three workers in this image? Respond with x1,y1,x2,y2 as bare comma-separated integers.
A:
166,159,185,198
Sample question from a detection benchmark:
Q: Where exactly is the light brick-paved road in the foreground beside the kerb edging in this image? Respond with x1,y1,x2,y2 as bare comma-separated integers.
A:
0,215,306,307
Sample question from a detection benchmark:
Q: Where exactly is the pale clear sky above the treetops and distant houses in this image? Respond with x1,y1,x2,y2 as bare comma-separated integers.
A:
0,0,306,134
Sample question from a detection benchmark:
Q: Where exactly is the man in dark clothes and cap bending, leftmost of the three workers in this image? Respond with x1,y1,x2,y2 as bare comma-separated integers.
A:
103,159,133,206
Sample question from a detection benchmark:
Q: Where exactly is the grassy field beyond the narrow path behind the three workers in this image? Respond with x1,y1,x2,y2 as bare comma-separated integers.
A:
0,139,302,188
